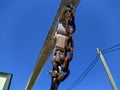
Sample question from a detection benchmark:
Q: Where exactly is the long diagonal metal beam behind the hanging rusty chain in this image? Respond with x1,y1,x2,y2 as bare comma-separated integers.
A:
26,0,80,90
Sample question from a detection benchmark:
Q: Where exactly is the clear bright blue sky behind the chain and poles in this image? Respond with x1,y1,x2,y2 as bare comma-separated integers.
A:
0,0,120,90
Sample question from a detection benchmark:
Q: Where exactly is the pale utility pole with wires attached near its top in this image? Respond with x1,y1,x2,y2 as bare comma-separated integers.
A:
97,48,118,90
